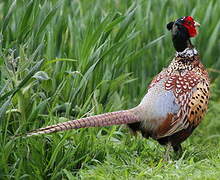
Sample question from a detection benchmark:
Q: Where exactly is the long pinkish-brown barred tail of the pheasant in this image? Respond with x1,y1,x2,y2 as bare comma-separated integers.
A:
22,109,140,136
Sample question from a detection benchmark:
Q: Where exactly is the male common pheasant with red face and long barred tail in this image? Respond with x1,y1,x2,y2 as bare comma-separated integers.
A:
22,16,210,151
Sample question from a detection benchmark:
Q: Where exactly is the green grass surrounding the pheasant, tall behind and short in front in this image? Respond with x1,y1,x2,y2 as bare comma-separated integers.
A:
0,0,220,179
